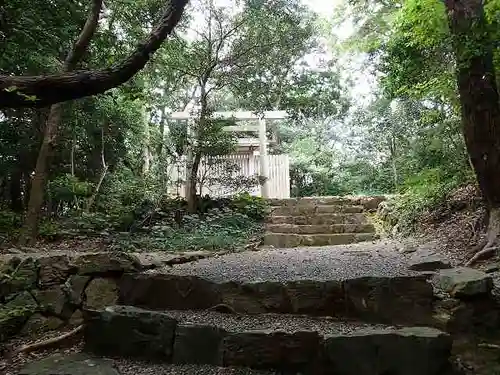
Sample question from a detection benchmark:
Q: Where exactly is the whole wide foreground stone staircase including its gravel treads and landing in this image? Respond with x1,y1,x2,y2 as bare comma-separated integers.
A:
12,242,500,375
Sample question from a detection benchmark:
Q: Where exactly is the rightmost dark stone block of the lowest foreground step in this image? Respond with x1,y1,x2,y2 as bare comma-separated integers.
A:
324,327,452,375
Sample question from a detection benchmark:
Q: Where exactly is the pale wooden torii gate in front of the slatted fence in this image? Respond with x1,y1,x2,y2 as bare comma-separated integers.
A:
170,111,288,198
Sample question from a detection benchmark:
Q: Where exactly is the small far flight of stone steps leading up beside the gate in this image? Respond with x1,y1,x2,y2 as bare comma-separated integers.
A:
264,197,383,248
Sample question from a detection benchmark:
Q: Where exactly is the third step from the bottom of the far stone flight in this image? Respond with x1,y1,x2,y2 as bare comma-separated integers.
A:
267,213,368,225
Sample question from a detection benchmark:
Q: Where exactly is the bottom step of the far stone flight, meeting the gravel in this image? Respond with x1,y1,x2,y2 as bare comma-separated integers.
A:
264,232,378,248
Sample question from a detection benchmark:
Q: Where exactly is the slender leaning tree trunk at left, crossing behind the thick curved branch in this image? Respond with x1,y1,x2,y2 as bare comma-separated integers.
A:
19,0,102,244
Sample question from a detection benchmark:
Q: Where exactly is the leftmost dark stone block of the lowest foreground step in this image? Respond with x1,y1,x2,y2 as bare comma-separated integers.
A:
84,306,177,361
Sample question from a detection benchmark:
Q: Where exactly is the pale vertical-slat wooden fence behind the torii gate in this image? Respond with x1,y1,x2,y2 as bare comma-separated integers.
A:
167,154,290,198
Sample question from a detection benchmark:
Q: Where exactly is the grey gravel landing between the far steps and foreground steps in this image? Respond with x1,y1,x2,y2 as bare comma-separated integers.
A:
151,240,416,282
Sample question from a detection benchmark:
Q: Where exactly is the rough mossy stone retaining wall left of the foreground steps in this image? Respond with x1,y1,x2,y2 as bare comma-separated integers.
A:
0,252,211,342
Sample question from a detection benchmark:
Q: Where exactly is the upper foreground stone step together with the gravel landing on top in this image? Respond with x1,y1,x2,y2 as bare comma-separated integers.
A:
119,246,434,324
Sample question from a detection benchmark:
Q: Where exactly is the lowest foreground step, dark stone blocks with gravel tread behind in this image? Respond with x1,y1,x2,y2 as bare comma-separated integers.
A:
84,306,452,375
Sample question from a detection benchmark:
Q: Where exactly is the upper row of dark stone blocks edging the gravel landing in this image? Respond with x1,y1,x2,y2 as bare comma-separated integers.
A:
118,268,439,326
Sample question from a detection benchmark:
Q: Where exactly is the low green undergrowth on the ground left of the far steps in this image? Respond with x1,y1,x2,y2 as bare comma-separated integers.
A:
0,193,267,251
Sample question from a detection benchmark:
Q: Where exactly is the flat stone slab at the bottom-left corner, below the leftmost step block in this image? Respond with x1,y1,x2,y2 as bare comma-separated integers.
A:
18,353,120,375
